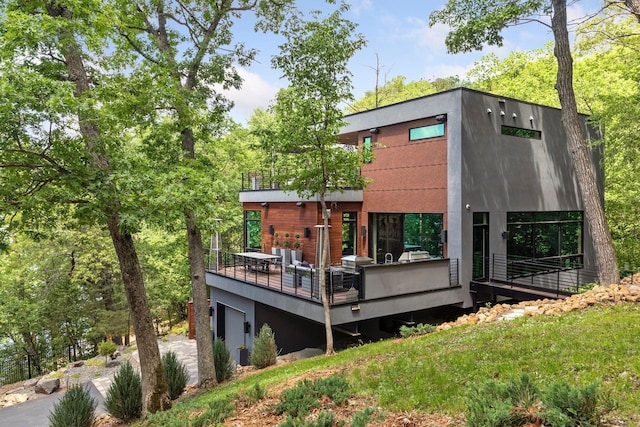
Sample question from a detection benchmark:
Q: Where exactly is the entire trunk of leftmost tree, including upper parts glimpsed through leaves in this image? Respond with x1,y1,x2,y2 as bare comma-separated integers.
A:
46,2,171,416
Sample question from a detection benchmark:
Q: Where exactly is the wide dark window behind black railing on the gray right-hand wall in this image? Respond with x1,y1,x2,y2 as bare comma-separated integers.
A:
507,211,584,267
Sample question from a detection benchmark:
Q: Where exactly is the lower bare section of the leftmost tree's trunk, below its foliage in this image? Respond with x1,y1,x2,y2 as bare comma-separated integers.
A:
108,215,171,417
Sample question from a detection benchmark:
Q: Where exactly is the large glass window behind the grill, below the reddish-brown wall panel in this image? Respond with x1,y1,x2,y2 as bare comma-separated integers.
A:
369,213,443,264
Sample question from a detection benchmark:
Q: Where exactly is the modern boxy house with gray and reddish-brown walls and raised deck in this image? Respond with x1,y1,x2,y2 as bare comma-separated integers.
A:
207,88,603,360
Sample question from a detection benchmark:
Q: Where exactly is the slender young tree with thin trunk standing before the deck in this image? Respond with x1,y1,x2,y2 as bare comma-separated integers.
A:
268,3,365,354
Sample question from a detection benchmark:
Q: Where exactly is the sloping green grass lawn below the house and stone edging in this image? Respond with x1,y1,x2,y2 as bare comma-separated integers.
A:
139,303,640,426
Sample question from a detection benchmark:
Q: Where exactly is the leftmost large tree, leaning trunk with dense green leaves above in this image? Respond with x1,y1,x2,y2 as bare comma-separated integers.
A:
0,1,170,413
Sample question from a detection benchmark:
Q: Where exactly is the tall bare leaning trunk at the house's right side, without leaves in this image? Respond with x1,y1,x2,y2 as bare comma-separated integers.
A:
551,0,620,285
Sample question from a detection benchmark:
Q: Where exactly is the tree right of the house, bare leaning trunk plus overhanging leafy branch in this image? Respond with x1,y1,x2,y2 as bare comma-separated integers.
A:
430,0,619,284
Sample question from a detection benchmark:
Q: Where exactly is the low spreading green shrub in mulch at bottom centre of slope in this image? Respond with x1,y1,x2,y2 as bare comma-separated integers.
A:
274,377,349,418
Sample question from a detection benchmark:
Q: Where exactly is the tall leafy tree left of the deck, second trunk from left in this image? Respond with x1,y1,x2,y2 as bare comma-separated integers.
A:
114,0,291,387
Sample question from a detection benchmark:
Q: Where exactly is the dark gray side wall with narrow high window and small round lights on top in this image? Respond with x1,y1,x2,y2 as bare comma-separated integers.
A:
458,91,603,304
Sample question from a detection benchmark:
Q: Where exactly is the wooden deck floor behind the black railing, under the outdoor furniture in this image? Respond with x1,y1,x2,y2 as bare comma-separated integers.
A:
208,264,359,305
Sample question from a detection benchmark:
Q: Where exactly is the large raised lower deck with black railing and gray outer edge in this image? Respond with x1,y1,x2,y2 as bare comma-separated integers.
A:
207,253,464,324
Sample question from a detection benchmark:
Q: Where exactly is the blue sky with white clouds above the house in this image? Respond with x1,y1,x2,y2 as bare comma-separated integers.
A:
226,0,600,123
